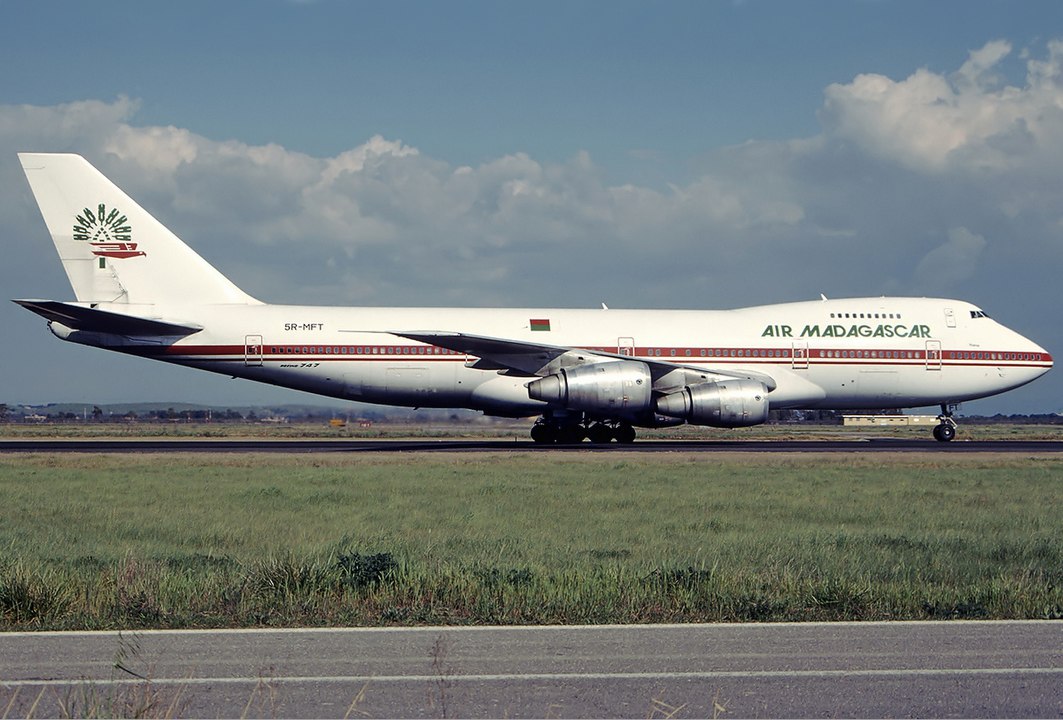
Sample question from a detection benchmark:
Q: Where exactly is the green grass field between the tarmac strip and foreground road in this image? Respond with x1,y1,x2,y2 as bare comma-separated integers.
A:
0,452,1063,630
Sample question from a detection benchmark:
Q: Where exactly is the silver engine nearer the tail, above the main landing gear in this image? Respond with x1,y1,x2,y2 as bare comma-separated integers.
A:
527,361,654,414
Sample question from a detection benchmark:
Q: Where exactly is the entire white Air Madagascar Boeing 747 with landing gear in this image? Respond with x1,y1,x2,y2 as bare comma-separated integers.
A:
14,153,1052,443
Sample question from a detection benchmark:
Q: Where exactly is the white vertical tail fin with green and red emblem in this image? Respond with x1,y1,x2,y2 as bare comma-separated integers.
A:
18,153,259,304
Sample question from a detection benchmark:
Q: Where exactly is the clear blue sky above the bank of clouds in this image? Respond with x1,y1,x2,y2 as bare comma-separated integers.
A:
6,0,1063,172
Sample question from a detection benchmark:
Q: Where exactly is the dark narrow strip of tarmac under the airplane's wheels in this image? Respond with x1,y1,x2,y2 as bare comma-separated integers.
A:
0,438,1063,455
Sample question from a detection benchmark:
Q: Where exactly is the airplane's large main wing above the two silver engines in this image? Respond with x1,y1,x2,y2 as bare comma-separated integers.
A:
389,331,777,390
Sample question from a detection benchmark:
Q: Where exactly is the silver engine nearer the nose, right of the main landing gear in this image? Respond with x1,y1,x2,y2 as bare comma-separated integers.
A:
657,380,767,428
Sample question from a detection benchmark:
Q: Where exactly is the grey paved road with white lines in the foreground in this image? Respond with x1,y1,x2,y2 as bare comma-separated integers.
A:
0,622,1063,718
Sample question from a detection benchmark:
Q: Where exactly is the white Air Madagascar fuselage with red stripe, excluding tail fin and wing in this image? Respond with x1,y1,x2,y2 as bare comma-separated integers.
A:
68,298,1052,417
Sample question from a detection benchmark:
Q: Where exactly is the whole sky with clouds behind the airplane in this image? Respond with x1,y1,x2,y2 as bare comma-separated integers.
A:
0,0,1063,414
